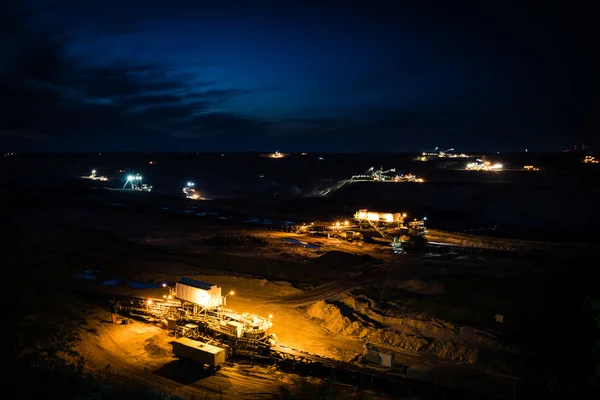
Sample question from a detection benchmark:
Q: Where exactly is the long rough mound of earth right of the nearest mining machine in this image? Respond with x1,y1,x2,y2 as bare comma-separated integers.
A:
307,300,478,364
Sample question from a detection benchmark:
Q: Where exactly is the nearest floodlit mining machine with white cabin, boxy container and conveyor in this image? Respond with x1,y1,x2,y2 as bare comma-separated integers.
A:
88,278,438,393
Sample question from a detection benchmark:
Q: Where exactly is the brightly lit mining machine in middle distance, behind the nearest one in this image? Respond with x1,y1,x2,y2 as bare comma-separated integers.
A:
287,209,427,250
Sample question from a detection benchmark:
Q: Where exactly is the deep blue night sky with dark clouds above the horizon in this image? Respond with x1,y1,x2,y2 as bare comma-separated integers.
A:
0,0,600,152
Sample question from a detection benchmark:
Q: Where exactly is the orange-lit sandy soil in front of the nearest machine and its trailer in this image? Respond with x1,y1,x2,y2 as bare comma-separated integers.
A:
77,308,388,400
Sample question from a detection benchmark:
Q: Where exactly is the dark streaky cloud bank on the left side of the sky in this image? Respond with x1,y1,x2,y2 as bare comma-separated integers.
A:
0,3,273,150
